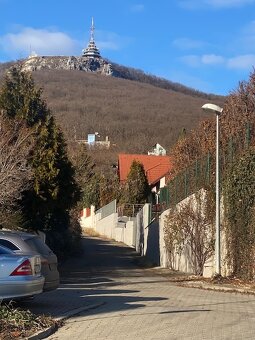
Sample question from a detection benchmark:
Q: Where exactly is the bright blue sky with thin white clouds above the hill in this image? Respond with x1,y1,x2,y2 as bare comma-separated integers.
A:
0,0,255,95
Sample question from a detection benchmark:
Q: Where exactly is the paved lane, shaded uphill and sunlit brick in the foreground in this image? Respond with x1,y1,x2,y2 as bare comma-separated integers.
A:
37,238,255,340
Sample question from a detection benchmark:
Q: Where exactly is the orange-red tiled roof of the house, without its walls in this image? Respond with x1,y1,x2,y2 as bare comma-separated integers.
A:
119,154,173,185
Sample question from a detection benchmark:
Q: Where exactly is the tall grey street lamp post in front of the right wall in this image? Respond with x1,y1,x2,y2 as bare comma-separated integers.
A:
202,104,223,275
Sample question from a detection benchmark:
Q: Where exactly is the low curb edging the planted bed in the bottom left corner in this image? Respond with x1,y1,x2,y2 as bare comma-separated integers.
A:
26,302,105,340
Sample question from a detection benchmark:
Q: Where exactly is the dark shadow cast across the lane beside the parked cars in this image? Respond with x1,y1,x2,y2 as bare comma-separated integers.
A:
22,238,170,317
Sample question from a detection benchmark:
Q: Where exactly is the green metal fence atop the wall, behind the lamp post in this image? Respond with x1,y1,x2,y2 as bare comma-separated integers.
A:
159,123,255,211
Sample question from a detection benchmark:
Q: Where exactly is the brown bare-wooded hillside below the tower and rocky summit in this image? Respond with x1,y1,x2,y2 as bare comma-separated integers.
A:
0,63,225,168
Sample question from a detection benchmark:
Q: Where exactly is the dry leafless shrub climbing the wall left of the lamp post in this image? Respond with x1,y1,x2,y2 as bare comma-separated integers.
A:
164,190,215,275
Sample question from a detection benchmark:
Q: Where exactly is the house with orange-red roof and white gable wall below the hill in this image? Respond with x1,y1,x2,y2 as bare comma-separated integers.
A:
118,154,173,203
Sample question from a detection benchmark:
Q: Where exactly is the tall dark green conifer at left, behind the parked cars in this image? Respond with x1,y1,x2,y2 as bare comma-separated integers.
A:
0,66,79,231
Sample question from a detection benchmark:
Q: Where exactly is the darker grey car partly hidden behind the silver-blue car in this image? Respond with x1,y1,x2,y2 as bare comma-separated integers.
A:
0,230,59,291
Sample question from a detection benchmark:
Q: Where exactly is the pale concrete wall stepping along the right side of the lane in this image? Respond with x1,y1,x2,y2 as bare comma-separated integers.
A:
81,193,229,277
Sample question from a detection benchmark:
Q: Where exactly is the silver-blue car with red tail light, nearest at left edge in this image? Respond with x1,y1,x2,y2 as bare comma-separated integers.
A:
0,246,44,301
